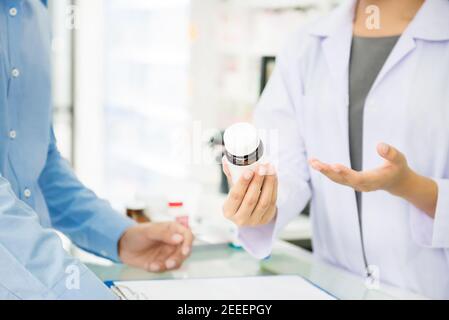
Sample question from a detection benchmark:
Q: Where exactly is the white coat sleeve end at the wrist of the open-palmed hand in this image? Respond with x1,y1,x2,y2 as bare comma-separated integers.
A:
410,178,449,248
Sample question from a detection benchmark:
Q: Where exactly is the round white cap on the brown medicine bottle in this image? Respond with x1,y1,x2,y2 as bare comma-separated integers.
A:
223,122,260,157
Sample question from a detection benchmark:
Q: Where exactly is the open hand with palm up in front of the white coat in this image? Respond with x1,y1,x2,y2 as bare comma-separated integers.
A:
309,143,413,197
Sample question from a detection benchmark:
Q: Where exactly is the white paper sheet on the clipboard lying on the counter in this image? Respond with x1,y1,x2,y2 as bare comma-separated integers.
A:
114,276,334,300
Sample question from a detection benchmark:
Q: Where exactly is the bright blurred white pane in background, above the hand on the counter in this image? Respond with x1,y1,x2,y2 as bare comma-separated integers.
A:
103,0,190,208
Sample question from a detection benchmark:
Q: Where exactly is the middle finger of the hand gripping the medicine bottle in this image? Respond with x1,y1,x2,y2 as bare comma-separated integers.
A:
233,165,267,226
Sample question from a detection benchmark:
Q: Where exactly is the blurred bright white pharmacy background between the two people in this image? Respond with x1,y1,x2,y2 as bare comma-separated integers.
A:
49,0,339,255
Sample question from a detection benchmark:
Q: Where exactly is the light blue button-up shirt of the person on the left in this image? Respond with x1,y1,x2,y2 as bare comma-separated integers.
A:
0,0,133,299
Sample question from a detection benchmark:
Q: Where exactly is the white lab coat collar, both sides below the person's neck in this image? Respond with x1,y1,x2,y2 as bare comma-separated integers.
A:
309,0,449,41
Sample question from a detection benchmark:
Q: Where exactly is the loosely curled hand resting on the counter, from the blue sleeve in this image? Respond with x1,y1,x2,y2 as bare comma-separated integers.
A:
119,222,193,272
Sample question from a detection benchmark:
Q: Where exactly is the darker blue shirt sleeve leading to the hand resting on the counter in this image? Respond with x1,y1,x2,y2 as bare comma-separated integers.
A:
39,130,134,261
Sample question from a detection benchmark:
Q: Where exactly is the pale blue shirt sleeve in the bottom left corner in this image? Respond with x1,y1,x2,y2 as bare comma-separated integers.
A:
0,176,115,299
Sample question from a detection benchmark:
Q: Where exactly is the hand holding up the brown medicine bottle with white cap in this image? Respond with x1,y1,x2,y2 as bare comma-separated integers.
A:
223,160,278,227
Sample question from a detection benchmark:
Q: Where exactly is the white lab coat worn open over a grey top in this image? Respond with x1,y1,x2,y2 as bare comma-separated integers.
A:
239,0,449,298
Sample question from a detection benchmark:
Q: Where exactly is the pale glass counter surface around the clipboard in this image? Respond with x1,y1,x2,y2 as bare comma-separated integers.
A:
86,241,424,299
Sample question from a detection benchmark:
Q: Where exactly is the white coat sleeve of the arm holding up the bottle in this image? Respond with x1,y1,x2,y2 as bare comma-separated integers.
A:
239,42,311,259
